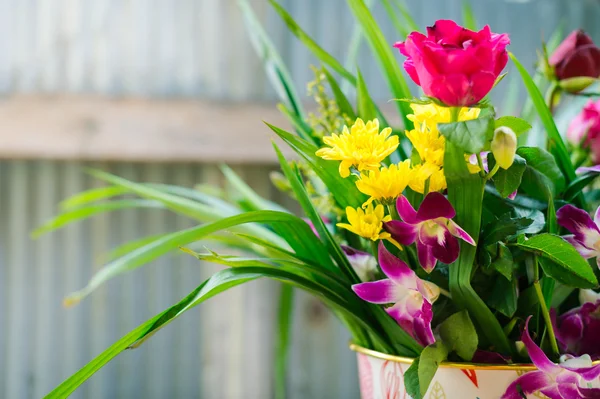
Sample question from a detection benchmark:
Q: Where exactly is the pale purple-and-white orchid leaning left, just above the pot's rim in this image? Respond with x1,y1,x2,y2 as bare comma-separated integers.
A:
352,242,439,346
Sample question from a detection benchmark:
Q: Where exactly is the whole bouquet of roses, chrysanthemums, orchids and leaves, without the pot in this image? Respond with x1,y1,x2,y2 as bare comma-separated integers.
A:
40,0,600,398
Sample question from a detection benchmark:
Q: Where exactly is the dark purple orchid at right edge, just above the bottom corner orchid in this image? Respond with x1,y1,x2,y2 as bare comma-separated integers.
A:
552,301,600,359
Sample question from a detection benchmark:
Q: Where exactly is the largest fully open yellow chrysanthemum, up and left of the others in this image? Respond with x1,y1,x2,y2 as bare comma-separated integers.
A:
316,118,398,177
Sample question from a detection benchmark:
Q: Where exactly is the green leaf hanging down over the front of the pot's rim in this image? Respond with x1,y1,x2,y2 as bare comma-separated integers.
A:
404,341,448,399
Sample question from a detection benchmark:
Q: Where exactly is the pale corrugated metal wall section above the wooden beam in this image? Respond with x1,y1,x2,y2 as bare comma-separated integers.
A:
0,0,600,101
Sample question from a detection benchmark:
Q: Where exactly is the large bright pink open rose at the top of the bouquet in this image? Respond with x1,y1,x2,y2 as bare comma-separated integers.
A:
394,20,510,107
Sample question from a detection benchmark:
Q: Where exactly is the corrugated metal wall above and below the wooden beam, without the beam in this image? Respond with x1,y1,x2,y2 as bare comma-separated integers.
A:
0,0,600,399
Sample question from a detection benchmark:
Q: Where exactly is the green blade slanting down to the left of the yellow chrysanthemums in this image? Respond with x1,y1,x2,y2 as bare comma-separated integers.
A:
267,123,367,209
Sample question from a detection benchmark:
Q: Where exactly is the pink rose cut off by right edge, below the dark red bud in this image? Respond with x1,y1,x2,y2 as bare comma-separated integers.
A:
567,100,600,164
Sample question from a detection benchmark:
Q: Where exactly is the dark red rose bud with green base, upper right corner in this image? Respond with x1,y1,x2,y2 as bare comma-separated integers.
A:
548,30,600,93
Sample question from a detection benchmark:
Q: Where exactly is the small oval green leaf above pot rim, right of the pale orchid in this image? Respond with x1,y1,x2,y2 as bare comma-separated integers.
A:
438,310,479,362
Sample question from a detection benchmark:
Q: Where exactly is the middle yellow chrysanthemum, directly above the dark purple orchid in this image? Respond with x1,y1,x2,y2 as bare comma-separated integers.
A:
356,160,412,208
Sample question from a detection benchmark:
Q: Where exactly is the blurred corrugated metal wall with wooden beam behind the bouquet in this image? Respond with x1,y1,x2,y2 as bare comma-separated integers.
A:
0,0,600,399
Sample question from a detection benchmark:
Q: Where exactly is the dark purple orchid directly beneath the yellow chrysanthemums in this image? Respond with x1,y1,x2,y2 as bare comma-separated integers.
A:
384,192,477,273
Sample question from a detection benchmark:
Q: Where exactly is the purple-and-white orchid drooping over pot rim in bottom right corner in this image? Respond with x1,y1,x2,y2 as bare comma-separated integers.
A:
502,317,600,399
